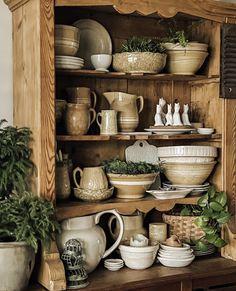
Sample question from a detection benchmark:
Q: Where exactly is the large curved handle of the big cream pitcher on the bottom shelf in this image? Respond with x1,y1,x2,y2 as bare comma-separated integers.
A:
95,209,124,259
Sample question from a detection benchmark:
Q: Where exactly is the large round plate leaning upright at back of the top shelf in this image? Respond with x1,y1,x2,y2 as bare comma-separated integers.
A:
73,19,112,69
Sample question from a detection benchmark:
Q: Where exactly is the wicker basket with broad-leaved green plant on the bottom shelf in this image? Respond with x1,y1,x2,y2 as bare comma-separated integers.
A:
163,186,231,251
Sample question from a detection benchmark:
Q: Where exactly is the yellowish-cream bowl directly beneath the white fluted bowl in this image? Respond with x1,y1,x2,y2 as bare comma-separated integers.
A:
163,162,216,185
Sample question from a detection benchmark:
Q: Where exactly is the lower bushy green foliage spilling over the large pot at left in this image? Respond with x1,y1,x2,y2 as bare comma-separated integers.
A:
0,191,59,253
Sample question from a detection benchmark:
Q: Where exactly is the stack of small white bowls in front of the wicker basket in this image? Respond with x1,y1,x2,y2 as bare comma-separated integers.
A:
157,244,195,268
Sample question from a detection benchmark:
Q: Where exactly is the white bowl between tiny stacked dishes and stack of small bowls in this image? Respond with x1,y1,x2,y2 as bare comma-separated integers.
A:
119,245,159,270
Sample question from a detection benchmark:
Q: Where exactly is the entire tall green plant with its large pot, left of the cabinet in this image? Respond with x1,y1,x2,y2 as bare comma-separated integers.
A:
0,120,59,291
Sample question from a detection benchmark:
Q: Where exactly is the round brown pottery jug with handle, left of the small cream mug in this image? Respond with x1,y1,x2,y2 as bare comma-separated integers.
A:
65,103,96,135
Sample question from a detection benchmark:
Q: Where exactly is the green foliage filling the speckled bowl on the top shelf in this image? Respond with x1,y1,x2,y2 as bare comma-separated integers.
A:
121,36,166,53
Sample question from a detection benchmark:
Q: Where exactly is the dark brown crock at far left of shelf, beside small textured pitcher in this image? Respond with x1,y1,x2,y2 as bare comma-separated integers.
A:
56,163,71,200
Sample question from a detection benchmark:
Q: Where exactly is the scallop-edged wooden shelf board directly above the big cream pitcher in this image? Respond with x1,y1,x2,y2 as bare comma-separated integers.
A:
56,195,199,221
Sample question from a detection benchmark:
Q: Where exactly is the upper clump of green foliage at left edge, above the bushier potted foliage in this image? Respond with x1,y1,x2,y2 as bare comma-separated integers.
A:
0,120,35,200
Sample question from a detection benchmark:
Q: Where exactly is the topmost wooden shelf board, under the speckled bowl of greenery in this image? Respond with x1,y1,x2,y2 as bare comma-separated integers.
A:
56,69,219,82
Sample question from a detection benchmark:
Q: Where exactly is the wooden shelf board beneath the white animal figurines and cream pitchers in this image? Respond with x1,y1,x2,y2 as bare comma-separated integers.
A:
57,134,222,141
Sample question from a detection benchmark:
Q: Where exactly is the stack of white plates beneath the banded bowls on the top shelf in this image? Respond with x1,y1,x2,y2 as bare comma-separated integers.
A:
56,56,84,70
